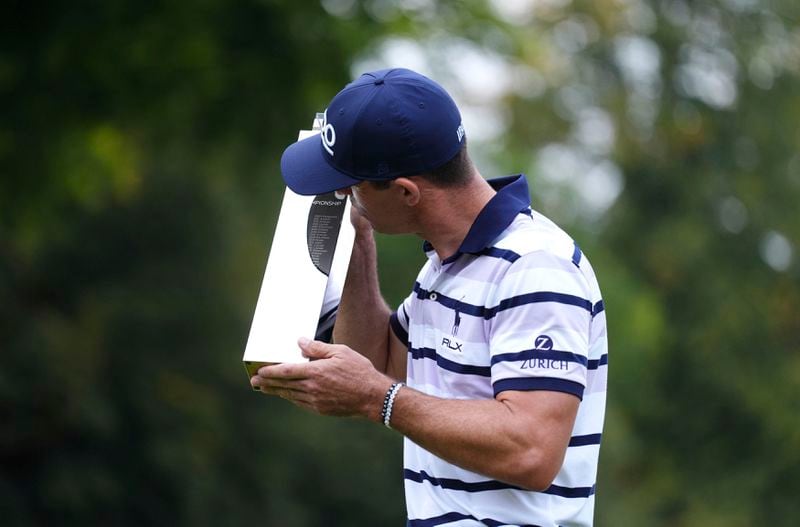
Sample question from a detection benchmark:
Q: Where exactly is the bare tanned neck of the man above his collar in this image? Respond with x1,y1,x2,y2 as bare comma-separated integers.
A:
418,174,496,260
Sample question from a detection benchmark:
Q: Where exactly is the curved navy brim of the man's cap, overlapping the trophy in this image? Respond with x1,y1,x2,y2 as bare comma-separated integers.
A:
281,135,360,196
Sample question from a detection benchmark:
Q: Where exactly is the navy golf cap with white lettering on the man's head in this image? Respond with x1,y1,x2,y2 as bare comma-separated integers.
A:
281,68,464,195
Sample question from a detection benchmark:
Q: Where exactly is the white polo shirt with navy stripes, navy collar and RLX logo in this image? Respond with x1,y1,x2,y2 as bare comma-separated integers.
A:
391,175,608,527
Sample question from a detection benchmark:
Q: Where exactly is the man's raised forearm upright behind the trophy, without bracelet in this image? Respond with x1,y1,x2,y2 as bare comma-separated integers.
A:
333,227,391,373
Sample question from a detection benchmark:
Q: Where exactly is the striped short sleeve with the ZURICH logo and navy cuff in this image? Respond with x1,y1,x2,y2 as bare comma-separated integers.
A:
487,251,592,399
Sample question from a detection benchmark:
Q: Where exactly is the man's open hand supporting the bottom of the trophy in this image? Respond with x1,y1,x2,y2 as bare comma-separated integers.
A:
250,338,392,421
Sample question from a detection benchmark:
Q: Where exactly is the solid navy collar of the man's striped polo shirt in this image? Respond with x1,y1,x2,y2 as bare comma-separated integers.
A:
423,174,531,263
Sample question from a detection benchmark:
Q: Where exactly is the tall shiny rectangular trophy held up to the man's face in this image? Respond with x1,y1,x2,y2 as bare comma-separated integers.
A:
243,113,355,384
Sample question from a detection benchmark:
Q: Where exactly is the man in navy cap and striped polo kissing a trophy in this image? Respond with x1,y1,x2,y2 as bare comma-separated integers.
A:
251,69,607,527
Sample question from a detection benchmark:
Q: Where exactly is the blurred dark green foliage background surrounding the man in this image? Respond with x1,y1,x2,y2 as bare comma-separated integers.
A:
0,0,800,527
